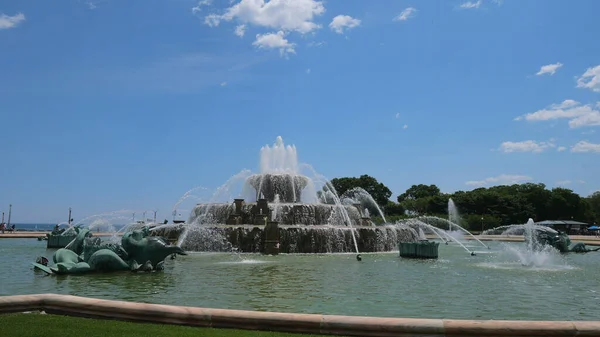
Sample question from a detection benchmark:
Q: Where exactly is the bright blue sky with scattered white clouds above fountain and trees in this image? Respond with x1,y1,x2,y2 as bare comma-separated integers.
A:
0,0,600,222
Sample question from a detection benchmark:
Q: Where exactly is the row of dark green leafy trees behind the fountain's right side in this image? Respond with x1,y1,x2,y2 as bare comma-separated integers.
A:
324,175,600,230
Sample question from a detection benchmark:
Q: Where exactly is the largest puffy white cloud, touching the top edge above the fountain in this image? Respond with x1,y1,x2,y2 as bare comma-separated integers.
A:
205,0,325,34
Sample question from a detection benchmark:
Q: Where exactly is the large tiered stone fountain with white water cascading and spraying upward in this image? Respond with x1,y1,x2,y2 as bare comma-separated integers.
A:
153,137,425,254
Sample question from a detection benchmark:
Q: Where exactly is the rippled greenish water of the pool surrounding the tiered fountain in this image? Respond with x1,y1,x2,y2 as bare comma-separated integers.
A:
0,239,600,320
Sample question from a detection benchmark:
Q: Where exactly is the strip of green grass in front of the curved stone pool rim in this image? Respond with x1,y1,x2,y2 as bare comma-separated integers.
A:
0,313,332,337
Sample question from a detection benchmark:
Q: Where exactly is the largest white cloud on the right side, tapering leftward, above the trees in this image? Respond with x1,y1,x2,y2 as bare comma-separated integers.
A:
515,99,600,129
